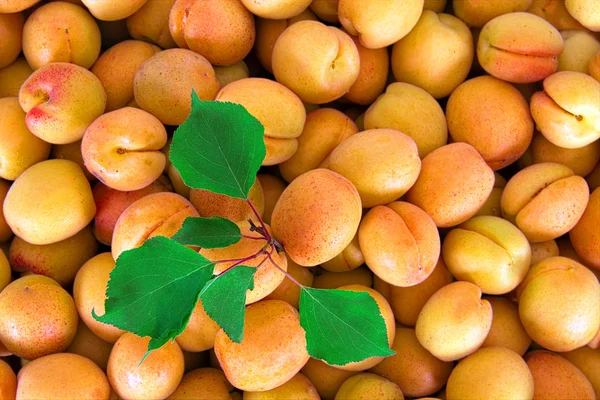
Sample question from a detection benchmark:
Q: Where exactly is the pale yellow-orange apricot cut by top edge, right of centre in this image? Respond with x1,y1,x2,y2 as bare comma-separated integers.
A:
338,0,423,49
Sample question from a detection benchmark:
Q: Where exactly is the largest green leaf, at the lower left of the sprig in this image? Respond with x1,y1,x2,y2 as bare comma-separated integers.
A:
92,236,214,357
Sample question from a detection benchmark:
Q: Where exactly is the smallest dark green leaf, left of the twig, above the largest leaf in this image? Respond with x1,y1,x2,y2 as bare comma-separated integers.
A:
172,217,242,249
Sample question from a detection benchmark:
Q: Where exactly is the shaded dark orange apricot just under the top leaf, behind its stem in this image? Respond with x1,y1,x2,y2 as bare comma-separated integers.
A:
190,179,265,221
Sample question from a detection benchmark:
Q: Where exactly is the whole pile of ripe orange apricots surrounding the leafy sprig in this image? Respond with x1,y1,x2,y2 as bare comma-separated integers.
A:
0,0,600,400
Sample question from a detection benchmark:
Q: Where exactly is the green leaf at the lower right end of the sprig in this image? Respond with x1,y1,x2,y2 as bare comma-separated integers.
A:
300,287,395,365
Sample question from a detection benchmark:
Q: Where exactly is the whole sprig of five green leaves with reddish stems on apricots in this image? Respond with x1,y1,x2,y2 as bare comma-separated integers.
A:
93,92,394,366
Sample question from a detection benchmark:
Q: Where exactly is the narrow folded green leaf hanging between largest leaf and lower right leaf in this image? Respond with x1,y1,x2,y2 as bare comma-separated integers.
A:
200,265,257,343
